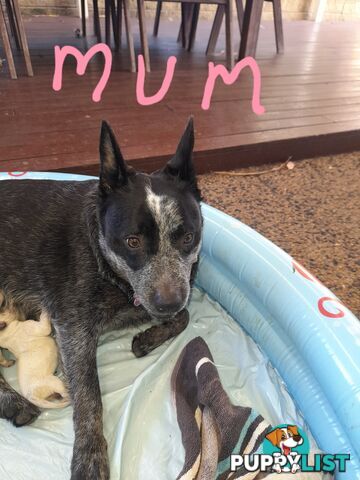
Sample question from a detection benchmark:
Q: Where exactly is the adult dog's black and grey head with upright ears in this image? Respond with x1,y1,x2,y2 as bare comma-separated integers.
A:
95,119,202,317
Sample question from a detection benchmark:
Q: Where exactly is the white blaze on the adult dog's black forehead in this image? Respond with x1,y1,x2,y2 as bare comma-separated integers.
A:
146,187,181,237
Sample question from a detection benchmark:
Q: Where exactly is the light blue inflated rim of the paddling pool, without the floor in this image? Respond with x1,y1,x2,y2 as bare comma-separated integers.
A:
0,172,360,480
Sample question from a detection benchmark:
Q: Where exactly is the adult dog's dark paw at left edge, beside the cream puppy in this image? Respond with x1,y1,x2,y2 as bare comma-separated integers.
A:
0,373,40,427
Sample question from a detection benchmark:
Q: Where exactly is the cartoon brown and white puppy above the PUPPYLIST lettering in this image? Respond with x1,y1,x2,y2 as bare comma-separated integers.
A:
265,425,308,473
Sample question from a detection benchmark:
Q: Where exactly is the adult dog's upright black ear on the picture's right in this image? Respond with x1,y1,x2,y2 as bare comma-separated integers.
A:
164,117,196,183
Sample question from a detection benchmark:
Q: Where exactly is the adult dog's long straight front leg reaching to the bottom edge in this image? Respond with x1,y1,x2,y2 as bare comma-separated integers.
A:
55,315,110,480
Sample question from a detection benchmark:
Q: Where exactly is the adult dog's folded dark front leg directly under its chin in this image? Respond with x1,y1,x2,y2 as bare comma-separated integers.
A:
132,309,189,357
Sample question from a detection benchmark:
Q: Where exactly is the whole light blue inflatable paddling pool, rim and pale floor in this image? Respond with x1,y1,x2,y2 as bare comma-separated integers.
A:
0,172,360,480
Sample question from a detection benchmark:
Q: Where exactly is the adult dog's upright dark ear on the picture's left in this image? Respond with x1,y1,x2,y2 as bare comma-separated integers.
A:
99,121,130,193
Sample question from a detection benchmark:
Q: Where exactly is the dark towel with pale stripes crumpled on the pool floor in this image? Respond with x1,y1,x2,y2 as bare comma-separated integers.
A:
172,337,270,480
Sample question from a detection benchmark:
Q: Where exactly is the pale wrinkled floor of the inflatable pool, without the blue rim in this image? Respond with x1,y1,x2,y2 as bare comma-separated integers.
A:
0,289,326,480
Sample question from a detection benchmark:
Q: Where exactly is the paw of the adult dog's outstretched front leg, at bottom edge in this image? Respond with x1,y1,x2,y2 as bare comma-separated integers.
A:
71,436,110,480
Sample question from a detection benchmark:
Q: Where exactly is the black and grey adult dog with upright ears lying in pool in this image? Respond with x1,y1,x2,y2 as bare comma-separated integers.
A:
0,119,202,480
